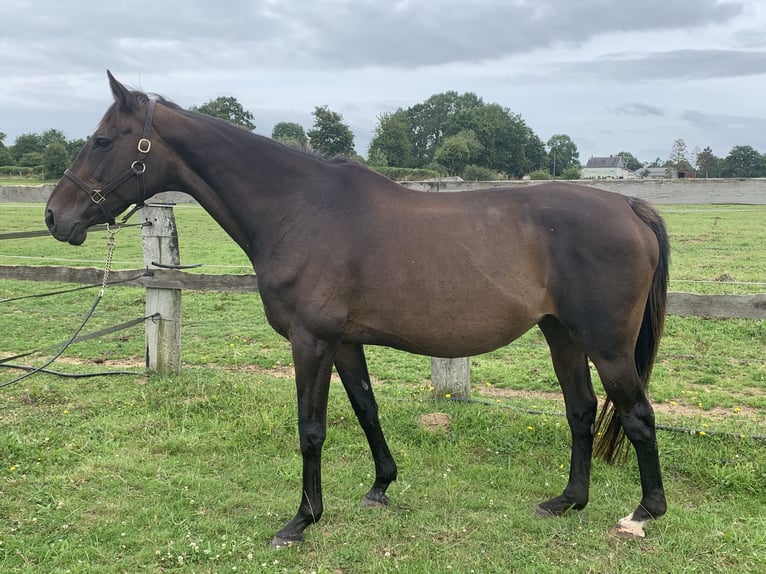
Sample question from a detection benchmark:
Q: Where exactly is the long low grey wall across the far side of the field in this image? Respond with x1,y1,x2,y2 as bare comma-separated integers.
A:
0,179,766,205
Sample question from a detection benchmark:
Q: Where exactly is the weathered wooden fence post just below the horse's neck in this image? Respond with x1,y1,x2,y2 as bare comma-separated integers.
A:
140,204,181,373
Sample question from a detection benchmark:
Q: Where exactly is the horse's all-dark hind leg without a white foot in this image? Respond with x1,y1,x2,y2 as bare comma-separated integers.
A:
537,316,598,516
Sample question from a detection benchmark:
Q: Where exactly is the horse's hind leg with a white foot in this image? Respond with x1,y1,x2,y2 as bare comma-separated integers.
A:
590,353,667,538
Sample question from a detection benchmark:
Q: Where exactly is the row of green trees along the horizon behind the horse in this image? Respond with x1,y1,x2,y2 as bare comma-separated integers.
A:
0,91,766,180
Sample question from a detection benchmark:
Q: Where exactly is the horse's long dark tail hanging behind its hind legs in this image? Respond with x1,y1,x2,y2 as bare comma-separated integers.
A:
594,197,670,464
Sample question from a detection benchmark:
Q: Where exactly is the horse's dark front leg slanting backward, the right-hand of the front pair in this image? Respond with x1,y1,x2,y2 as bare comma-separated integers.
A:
335,344,396,506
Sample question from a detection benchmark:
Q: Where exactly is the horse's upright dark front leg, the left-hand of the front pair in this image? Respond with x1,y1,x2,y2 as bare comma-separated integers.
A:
271,334,334,548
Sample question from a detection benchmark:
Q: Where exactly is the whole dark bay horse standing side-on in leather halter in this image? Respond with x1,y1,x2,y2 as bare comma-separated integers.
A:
45,74,669,546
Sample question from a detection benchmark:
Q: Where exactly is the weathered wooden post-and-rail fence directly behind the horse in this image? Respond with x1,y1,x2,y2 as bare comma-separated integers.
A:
0,204,766,397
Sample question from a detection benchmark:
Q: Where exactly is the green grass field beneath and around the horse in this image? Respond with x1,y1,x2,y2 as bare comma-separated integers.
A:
0,204,766,573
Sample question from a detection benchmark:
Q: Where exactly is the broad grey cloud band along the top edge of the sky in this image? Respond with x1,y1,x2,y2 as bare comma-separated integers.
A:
0,0,742,72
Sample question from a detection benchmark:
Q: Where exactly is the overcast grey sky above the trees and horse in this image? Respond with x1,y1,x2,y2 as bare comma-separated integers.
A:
0,0,766,164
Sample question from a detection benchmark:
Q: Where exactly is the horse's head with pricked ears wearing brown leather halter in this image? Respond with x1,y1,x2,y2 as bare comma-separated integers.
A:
45,72,170,245
